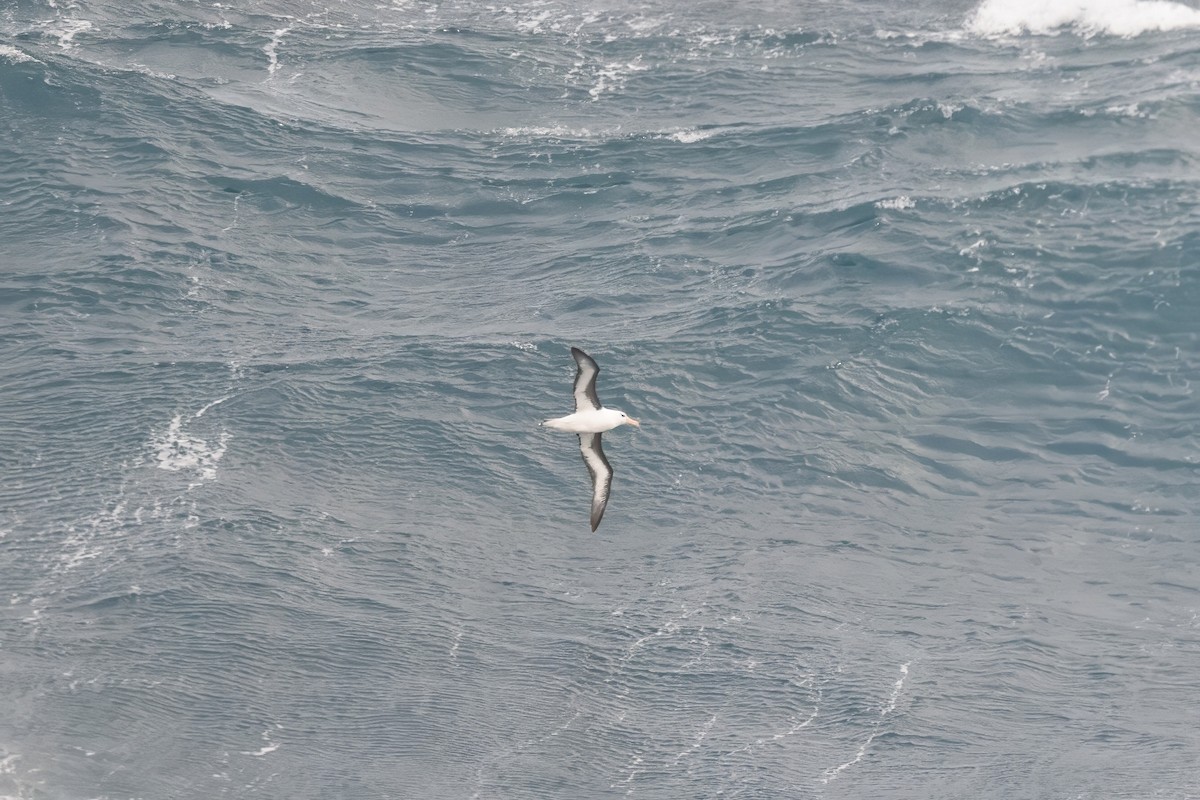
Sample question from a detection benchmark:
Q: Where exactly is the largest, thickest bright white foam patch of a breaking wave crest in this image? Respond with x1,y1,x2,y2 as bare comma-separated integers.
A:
967,0,1200,36
